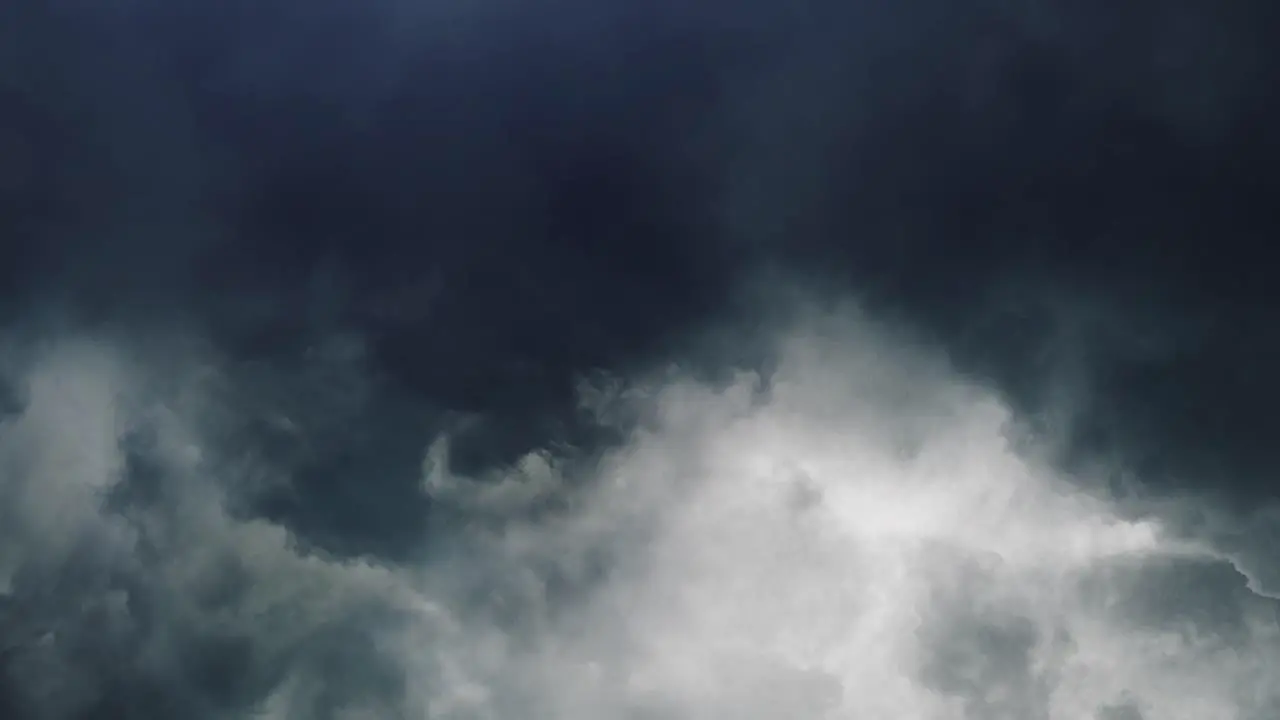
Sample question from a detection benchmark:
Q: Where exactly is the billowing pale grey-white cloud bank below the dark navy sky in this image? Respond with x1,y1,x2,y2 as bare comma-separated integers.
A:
0,299,1280,720
